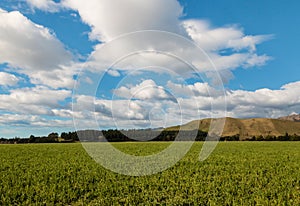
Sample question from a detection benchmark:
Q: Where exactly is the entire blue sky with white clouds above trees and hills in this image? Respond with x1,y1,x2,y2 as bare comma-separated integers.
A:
0,0,300,137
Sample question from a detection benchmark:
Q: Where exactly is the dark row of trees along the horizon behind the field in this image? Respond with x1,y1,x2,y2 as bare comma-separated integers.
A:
0,129,300,144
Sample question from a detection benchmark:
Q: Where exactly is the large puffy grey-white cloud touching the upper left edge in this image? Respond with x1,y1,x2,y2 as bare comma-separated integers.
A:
0,10,75,88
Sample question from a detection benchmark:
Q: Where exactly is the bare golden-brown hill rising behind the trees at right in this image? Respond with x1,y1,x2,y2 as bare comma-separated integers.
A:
166,117,300,139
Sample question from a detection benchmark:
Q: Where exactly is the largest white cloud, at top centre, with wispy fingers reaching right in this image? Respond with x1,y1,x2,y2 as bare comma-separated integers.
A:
64,0,273,82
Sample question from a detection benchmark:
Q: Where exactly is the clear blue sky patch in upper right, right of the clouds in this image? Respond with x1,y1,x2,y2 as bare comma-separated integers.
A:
181,0,300,90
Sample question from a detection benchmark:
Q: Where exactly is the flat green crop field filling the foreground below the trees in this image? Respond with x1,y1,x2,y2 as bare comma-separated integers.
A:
0,142,300,205
